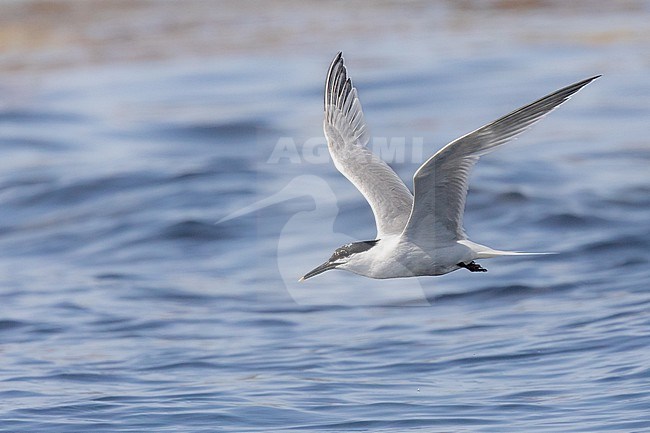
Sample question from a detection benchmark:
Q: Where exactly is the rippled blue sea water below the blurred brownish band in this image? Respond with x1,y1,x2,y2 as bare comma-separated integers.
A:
0,1,650,432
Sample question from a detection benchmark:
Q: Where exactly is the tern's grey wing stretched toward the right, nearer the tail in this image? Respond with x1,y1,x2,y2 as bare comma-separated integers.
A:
404,75,600,243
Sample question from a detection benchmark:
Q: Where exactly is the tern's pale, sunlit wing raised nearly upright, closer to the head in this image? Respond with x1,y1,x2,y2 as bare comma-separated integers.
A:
323,52,413,239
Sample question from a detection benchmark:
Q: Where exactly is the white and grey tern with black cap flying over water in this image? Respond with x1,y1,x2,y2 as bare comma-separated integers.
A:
300,52,600,281
